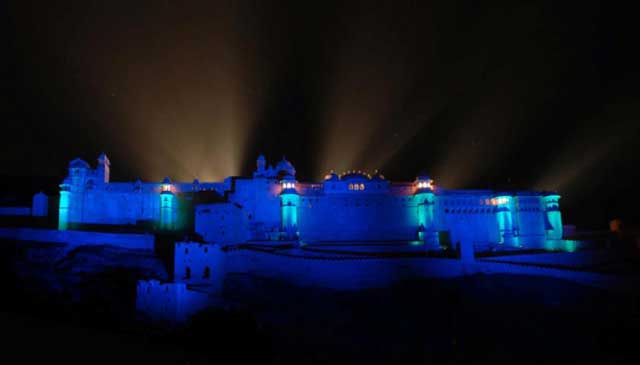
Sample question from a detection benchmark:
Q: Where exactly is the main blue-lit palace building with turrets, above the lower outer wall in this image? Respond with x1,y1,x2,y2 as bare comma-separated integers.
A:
59,154,562,249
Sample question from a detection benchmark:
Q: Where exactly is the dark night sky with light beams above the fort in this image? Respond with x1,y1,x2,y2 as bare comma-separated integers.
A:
5,0,640,227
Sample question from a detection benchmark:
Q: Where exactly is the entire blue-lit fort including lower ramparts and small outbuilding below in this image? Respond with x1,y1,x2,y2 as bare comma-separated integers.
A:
0,154,592,322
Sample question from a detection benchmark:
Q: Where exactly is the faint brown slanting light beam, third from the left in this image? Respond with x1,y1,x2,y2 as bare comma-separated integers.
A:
424,51,576,188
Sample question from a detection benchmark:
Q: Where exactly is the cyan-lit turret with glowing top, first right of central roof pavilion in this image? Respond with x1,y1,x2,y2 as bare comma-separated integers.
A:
414,176,439,248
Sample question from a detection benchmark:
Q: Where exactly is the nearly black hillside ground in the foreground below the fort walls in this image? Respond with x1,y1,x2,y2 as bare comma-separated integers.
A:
0,239,640,364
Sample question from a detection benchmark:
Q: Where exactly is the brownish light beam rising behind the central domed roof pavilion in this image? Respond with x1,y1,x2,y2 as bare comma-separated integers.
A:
315,2,433,178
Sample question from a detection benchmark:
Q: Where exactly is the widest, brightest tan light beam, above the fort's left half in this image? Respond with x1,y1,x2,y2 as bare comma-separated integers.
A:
62,4,264,181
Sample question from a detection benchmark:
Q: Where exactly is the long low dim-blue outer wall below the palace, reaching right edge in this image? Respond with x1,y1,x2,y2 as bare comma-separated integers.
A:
225,246,640,290
